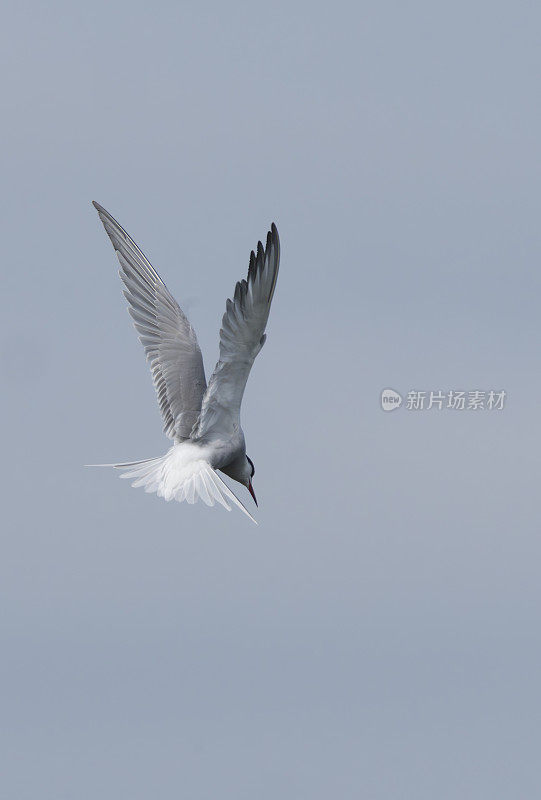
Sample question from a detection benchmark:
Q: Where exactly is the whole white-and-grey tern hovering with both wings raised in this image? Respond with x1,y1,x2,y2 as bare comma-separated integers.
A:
89,203,280,524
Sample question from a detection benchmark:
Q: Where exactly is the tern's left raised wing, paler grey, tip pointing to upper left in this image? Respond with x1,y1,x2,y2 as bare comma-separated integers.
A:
93,203,206,442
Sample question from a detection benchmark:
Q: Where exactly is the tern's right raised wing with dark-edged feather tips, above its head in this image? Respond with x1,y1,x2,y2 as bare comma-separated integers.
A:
192,223,280,440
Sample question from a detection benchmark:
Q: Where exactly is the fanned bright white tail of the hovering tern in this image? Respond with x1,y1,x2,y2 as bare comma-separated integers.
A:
87,445,257,525
